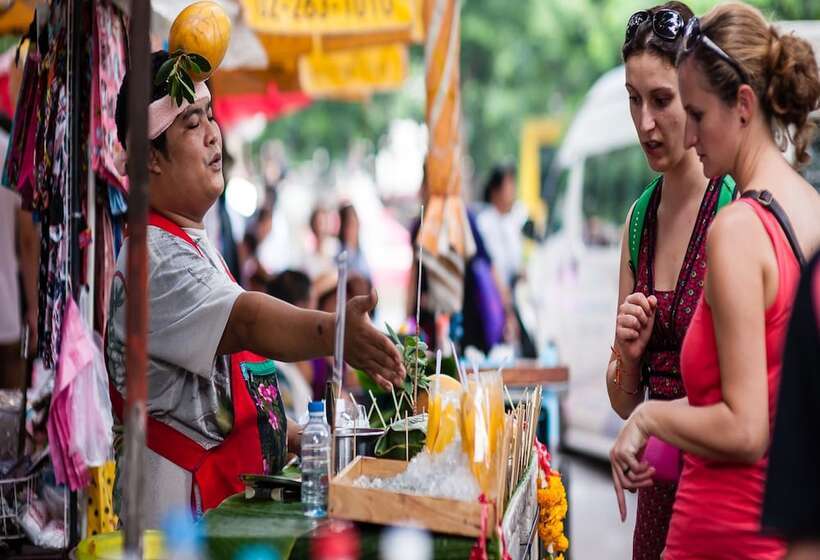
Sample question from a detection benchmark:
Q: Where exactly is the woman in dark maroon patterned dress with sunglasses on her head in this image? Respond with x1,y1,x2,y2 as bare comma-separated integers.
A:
606,2,722,560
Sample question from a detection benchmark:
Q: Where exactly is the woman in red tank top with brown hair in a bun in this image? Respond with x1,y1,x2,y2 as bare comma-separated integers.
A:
611,4,820,560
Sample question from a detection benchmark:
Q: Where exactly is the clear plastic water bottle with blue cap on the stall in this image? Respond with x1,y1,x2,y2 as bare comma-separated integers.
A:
302,401,330,517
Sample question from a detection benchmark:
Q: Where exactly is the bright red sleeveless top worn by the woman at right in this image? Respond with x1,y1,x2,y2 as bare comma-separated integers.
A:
664,198,800,560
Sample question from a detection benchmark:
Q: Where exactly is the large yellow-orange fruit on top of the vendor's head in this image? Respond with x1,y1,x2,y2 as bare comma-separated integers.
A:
168,0,231,82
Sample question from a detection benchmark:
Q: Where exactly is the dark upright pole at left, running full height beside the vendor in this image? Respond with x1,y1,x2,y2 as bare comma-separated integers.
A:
124,0,151,558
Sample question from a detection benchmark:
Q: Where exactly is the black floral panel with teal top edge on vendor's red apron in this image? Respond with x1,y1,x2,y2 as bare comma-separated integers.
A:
241,360,288,474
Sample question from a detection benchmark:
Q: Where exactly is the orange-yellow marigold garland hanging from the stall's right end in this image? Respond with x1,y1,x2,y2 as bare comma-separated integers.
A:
536,440,569,560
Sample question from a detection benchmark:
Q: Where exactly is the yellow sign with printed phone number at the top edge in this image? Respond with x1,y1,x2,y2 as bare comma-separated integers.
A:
242,0,414,36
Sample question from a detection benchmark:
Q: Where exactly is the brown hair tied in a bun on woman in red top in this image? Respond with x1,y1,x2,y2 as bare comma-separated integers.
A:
678,4,820,167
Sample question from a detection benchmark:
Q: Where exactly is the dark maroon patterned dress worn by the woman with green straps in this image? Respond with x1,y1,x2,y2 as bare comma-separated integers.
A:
632,179,721,560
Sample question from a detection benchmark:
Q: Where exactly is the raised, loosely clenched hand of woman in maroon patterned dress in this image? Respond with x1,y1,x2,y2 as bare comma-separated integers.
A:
615,292,658,371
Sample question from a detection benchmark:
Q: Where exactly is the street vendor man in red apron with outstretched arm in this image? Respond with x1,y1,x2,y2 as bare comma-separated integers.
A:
106,51,405,527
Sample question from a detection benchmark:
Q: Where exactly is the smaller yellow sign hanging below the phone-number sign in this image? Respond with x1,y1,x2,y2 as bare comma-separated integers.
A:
299,45,407,98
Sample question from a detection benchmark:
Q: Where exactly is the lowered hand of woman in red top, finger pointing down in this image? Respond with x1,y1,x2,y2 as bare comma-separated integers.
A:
609,405,655,522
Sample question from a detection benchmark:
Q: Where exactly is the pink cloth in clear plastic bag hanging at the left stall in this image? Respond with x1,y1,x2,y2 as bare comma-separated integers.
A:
47,297,94,490
